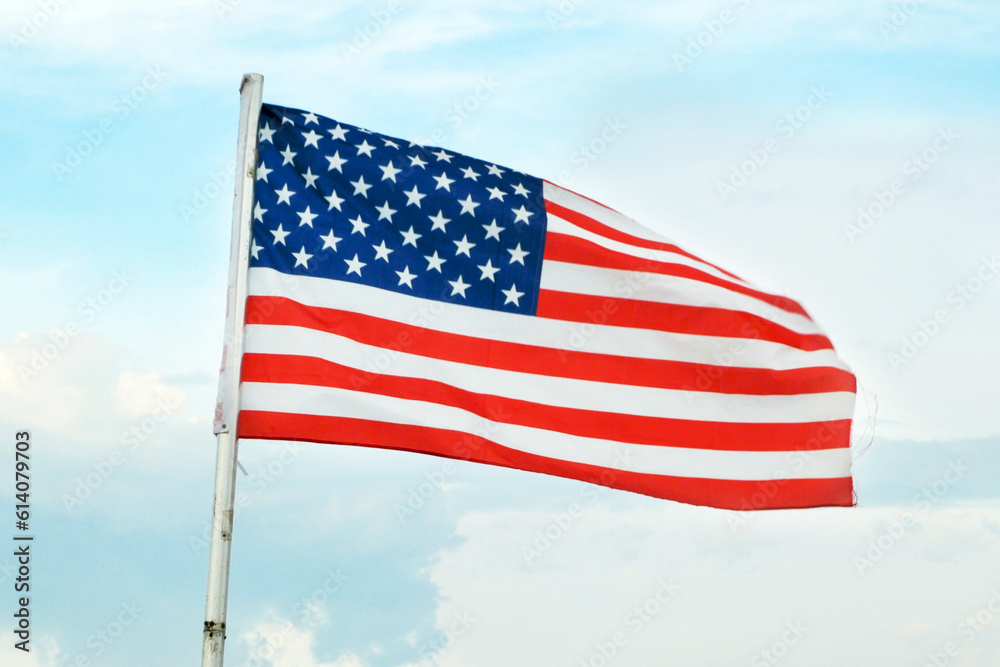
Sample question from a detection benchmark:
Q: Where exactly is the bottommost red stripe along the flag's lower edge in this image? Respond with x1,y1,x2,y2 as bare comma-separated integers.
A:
238,410,853,510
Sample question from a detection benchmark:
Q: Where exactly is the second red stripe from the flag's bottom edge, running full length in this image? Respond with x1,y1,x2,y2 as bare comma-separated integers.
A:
241,353,851,451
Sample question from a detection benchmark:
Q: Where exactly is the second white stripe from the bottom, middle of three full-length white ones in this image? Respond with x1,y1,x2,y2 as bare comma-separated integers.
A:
246,325,854,424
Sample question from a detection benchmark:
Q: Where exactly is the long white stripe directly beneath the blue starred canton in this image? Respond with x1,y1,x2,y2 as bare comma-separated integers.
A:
249,267,847,370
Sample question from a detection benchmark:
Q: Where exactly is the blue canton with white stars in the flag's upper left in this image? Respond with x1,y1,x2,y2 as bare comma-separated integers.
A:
250,104,546,315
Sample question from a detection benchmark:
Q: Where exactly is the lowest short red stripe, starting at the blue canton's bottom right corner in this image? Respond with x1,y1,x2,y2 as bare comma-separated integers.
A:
535,289,833,352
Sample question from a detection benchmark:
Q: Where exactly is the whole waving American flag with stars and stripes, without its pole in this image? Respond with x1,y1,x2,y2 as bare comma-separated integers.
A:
230,104,855,509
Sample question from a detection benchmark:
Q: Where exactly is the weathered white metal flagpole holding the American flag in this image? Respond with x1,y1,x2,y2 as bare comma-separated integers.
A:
201,74,264,667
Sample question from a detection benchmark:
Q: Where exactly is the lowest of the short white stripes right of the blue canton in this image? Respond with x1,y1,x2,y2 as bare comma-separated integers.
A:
541,260,823,334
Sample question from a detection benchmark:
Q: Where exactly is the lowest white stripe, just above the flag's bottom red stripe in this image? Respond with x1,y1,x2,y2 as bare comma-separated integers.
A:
241,382,851,480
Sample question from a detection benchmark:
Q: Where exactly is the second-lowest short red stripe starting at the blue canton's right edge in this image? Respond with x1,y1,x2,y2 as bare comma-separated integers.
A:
545,232,809,318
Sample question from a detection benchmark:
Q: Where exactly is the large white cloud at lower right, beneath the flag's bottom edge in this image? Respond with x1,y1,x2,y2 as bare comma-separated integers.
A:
422,501,1000,667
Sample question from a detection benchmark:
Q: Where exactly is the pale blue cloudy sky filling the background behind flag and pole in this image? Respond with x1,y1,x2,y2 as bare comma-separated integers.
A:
0,0,1000,667
